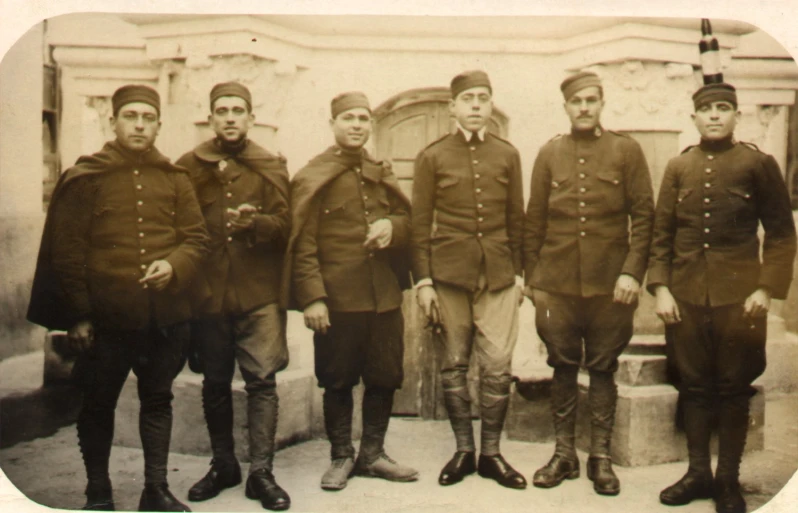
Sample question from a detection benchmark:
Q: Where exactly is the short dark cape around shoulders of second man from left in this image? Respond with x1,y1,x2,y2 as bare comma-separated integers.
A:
177,138,289,201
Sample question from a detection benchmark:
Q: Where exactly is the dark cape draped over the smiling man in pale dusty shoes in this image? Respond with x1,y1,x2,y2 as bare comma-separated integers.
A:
280,146,411,310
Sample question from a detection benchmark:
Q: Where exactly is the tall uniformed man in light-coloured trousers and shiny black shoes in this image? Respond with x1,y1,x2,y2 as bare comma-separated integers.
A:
412,71,526,489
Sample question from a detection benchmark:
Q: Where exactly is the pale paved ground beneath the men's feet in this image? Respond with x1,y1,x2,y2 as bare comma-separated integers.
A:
0,394,798,513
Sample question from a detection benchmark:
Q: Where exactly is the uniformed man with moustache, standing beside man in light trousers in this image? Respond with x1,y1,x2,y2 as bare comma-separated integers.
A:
524,72,654,495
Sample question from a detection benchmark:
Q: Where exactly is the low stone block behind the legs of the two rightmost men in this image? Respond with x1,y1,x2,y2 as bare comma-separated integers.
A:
505,375,765,467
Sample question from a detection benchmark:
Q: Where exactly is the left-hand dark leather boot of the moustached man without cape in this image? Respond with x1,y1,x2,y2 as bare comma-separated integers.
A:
533,365,579,488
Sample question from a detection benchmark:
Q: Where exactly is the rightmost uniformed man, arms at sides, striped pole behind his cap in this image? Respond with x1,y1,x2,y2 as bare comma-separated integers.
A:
648,83,796,513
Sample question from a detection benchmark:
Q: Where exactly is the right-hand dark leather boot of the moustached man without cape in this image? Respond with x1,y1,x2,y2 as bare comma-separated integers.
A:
587,370,621,495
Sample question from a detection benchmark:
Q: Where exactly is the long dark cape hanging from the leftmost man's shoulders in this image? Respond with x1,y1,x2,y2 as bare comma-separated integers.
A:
27,141,186,330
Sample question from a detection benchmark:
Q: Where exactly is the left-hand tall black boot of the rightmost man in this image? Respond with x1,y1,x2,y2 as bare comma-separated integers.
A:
659,394,713,506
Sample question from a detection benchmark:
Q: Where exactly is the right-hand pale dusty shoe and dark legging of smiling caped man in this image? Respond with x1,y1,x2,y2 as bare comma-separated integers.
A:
354,387,418,482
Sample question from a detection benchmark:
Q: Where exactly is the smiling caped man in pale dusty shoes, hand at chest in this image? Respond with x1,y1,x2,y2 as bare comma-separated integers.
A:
283,92,418,490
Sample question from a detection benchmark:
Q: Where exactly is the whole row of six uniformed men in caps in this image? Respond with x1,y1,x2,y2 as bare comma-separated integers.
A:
29,64,796,513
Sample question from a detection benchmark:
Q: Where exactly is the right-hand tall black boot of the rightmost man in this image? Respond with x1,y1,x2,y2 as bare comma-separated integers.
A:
715,395,749,513
